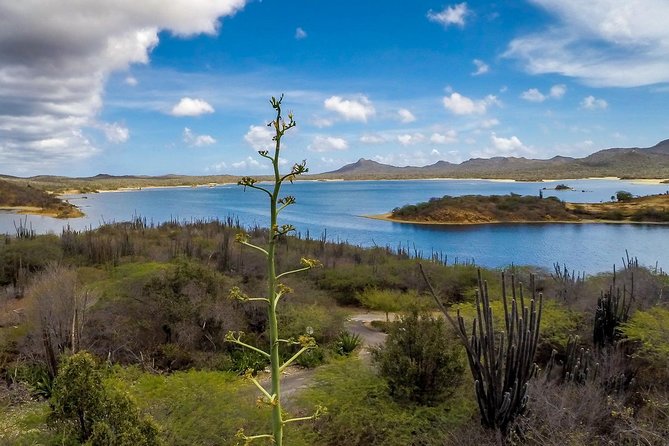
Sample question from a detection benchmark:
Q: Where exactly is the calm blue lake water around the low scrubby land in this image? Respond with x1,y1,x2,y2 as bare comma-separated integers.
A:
0,180,669,274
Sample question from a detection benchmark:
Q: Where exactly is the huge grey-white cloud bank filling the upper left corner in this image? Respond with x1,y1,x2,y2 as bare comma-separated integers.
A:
0,0,246,172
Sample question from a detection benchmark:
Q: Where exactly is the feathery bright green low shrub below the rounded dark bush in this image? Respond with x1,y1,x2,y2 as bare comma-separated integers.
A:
291,357,476,446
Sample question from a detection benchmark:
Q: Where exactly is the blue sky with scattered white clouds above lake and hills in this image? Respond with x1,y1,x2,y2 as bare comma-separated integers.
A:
0,0,669,176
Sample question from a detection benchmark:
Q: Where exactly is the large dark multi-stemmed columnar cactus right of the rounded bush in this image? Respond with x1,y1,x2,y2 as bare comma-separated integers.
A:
421,266,543,434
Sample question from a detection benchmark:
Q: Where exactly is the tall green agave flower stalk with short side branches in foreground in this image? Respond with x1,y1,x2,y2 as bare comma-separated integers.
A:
226,95,323,446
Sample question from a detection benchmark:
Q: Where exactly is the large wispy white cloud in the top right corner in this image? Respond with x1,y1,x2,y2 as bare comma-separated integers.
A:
505,0,669,87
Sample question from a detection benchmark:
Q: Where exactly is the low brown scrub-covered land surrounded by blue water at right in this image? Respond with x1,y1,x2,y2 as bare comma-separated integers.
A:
371,194,669,224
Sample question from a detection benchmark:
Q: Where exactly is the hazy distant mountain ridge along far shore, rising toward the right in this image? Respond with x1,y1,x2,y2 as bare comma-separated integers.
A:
315,139,669,180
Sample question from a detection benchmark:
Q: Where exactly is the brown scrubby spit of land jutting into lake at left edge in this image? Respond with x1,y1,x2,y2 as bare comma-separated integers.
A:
0,180,84,218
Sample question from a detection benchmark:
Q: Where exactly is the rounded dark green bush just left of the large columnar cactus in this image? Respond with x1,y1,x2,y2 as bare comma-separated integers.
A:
372,311,464,405
